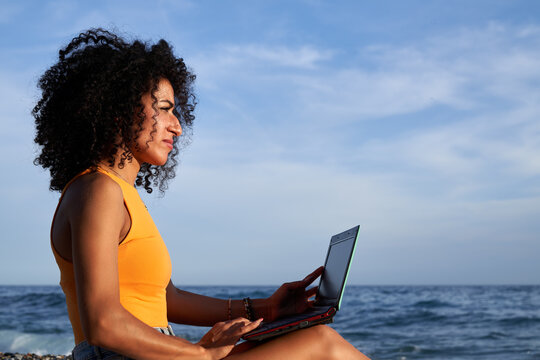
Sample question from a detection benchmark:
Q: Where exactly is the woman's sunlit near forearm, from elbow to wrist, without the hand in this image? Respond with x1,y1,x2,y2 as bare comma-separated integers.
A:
85,308,209,360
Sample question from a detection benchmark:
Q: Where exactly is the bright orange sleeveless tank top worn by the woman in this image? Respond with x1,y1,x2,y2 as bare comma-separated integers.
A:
51,168,171,344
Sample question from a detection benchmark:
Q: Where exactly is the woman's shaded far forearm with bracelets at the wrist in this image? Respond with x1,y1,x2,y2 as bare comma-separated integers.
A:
167,283,269,326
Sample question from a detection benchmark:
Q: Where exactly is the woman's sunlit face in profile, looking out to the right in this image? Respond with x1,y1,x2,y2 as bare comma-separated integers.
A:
131,79,182,165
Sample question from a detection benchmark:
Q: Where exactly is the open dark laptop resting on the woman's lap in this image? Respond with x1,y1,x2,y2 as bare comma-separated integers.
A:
242,225,360,340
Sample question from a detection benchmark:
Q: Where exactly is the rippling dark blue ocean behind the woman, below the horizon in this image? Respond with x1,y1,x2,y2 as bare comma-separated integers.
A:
0,286,540,360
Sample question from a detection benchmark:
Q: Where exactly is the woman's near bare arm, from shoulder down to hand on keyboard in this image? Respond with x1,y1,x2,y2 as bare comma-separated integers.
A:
69,176,251,359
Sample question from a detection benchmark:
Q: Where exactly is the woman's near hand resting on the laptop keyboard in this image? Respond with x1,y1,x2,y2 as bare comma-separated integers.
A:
197,318,263,359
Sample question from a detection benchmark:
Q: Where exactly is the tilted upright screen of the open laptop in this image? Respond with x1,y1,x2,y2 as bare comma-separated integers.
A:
316,226,359,310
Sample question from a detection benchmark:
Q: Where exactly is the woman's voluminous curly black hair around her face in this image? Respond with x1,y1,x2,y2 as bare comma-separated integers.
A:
32,28,196,193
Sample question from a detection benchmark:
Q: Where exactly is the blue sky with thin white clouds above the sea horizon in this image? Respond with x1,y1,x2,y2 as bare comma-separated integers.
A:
0,0,540,285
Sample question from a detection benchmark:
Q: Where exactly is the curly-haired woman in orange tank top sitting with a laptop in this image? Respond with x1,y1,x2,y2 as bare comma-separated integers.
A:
33,29,372,360
